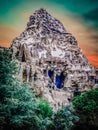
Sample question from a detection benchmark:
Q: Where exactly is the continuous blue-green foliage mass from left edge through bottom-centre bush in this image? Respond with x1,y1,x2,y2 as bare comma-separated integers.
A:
0,50,78,130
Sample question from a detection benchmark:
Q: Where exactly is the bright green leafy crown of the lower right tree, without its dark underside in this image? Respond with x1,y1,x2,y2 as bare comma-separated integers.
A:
73,88,98,113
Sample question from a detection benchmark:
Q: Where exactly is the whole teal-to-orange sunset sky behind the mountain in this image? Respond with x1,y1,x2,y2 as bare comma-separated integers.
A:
0,0,98,67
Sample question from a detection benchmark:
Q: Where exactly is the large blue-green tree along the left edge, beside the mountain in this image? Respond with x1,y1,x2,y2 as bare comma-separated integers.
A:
0,50,51,130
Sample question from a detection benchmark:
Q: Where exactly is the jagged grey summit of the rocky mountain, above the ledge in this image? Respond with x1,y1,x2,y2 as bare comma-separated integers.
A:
27,8,66,33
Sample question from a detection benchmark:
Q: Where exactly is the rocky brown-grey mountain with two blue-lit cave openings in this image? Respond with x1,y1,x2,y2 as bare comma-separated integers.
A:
11,8,96,110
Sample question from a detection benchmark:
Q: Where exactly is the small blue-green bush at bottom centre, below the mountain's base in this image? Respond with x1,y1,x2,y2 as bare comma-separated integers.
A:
53,106,79,130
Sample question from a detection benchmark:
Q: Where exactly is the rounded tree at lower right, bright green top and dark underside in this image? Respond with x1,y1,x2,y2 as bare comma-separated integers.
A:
73,88,98,129
